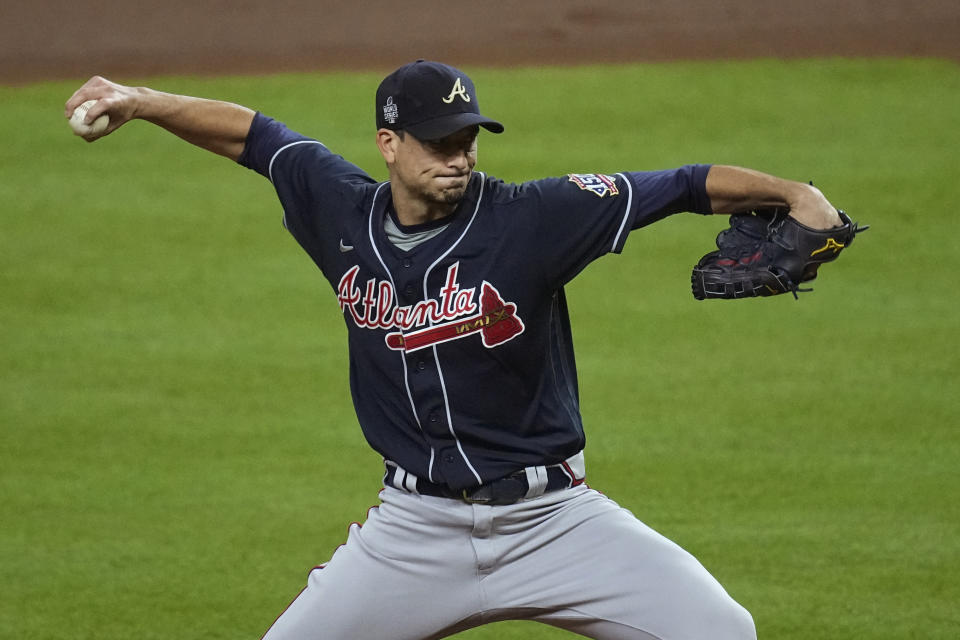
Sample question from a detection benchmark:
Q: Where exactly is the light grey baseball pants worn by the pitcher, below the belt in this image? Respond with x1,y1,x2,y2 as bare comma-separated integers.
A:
264,486,756,640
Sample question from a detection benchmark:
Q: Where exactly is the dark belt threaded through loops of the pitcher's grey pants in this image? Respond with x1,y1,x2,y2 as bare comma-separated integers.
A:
383,462,583,506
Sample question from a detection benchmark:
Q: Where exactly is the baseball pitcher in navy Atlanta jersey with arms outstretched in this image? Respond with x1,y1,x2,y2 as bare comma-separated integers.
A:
65,60,856,640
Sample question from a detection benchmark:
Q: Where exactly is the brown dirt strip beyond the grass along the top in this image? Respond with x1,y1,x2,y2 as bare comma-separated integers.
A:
0,0,960,84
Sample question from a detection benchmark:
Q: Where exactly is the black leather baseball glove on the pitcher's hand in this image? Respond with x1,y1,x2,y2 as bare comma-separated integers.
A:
690,209,869,300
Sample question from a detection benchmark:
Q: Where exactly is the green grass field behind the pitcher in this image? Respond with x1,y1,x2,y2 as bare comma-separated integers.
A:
0,59,960,640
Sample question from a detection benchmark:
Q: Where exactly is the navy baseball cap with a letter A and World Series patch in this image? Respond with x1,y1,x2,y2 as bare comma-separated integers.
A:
377,60,503,140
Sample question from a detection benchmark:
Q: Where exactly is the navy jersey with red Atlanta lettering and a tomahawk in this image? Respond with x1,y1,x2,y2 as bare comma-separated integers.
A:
239,114,710,489
